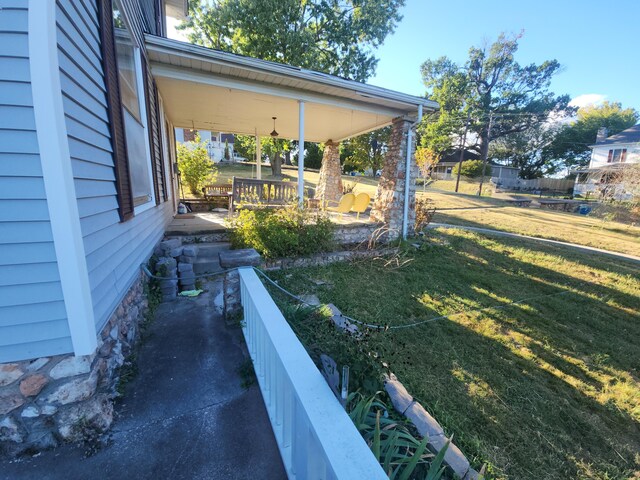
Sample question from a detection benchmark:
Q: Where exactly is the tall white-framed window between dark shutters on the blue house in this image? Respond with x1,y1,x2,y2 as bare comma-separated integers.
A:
112,0,153,207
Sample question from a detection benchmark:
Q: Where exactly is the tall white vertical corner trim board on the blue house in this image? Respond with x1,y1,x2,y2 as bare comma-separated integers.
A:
29,0,97,355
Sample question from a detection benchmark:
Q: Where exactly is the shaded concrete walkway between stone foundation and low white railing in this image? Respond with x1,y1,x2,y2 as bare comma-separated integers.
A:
0,280,286,480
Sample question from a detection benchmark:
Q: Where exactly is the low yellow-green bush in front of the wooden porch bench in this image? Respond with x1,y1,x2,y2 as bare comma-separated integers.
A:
229,206,334,258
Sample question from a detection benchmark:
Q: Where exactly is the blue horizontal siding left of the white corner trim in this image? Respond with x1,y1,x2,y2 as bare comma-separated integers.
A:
0,0,73,363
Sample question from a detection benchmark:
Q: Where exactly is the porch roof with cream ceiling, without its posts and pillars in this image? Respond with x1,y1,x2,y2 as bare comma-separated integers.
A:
145,35,438,142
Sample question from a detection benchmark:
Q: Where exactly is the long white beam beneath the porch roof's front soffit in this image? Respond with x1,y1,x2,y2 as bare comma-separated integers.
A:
151,62,406,118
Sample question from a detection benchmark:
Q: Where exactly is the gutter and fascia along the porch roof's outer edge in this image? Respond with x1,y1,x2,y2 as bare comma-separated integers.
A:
145,35,440,113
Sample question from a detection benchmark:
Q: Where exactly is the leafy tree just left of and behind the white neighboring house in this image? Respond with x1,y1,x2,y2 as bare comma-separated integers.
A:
543,102,640,169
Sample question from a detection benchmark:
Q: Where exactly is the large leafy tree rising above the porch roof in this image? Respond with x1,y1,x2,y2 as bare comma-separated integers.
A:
179,0,405,81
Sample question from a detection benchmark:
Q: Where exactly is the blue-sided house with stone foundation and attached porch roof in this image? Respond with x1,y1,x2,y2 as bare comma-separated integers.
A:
0,0,437,451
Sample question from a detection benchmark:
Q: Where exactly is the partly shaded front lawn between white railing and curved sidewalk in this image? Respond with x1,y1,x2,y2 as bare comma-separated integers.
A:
264,229,640,480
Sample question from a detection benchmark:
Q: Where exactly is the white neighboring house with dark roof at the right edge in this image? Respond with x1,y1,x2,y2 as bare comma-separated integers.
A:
573,124,640,200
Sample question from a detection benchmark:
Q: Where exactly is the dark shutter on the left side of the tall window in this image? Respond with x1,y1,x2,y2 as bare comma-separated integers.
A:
100,0,133,221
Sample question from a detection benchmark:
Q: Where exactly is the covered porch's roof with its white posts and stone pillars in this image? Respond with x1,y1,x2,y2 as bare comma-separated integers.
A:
145,36,437,233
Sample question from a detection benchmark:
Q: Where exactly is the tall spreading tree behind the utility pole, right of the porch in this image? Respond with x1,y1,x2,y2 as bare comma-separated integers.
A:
421,34,571,176
